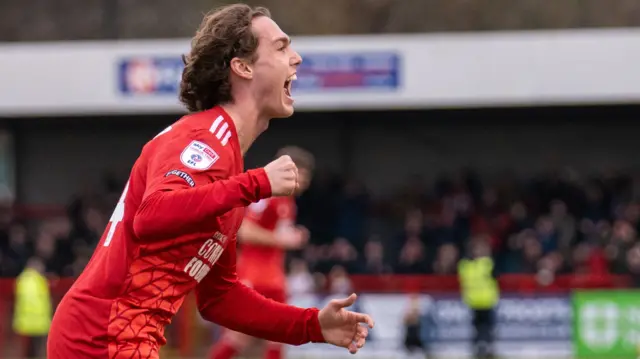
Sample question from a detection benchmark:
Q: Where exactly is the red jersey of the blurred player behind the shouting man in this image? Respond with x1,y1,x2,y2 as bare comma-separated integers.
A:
238,197,297,290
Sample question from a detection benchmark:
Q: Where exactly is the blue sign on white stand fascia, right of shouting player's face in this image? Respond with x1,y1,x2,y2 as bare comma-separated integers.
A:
293,52,401,92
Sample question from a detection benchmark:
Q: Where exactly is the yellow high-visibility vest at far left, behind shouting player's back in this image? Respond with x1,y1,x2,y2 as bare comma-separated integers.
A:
13,268,52,336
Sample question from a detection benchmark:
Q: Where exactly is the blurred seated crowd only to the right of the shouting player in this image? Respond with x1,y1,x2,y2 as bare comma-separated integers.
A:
292,170,640,284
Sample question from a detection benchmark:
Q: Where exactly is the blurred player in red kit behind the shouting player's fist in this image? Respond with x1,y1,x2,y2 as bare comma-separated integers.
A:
210,147,314,359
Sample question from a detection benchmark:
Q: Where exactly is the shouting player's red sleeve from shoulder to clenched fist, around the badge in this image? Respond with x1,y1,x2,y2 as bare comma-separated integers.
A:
133,129,271,242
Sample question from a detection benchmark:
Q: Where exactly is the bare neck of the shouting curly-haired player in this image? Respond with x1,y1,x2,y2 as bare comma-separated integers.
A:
222,102,268,156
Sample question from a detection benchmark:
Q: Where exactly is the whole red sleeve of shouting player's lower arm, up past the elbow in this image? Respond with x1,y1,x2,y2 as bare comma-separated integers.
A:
196,243,324,345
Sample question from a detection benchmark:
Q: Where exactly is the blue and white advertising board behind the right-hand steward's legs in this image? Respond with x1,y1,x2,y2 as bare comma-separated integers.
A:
425,295,572,357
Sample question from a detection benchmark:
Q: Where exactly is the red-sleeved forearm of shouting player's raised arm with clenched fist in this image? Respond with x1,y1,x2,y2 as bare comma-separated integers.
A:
133,169,271,241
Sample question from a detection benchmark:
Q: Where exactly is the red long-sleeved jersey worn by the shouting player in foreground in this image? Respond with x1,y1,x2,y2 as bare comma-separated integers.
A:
47,108,321,359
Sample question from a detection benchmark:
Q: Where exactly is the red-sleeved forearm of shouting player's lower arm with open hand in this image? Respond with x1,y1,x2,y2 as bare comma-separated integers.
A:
200,283,324,345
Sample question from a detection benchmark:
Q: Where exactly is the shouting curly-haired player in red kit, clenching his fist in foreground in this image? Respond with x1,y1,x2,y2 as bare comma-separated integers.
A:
47,5,373,359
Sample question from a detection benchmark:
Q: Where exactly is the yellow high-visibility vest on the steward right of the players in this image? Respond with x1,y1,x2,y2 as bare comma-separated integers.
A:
458,257,500,309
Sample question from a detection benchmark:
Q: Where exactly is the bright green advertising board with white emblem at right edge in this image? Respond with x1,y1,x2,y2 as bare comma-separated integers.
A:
573,291,640,359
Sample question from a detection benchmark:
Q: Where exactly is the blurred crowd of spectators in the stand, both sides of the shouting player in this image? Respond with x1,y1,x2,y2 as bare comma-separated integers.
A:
0,169,640,291
